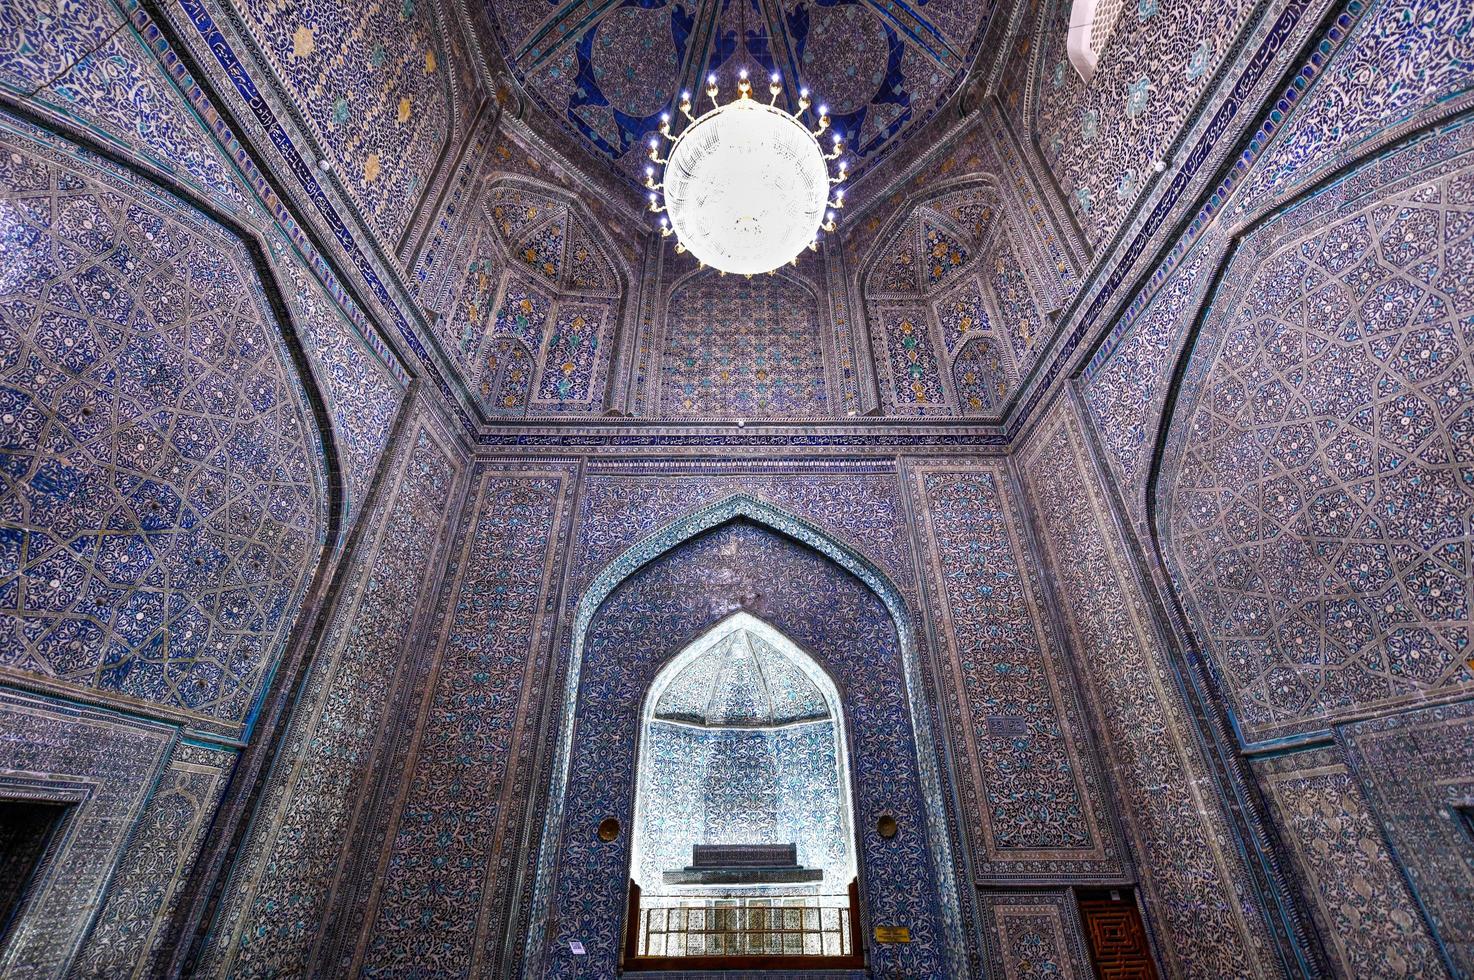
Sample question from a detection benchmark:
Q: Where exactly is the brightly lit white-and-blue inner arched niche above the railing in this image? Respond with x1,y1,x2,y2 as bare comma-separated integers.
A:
629,612,855,931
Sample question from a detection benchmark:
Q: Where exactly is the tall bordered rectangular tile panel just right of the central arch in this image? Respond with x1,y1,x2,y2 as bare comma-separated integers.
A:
905,460,1129,884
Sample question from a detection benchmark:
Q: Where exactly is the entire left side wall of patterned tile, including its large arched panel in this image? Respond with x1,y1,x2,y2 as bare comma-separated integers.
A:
0,3,430,977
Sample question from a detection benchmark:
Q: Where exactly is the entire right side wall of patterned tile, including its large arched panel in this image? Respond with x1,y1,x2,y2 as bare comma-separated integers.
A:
1080,3,1474,976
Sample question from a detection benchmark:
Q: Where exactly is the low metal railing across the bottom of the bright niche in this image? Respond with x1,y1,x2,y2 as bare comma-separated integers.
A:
638,896,853,956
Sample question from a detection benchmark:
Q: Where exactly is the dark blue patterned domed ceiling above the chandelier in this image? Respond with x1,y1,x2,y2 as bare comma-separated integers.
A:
489,0,992,180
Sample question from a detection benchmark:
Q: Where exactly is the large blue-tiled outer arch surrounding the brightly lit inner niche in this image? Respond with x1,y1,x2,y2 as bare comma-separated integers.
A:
523,495,967,977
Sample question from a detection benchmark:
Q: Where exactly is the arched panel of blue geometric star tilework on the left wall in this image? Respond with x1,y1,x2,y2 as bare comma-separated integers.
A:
0,129,324,722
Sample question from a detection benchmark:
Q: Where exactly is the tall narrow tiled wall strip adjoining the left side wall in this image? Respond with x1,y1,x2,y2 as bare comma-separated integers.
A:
199,394,466,977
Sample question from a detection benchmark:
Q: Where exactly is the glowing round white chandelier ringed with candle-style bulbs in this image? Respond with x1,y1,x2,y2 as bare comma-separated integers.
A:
646,69,848,276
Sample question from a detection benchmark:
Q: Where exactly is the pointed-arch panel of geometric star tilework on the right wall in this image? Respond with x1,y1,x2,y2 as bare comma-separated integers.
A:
1164,167,1474,734
